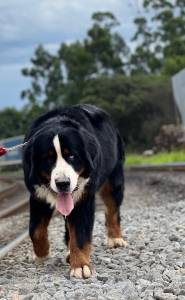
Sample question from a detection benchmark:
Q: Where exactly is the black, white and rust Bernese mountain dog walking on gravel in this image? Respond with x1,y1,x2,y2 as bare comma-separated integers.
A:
23,104,126,278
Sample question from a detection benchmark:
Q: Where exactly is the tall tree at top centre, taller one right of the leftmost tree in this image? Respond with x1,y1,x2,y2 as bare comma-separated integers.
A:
85,12,129,75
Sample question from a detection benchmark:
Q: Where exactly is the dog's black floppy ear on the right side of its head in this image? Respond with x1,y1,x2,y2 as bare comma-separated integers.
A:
80,129,101,177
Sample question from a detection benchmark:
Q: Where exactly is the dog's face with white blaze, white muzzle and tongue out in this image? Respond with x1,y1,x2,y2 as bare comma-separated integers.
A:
35,133,89,216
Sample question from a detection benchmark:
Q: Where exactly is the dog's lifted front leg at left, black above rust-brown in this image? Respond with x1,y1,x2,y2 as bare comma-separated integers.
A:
29,196,53,262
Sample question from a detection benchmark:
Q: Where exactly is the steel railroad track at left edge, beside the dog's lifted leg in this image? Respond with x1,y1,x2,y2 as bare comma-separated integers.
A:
0,177,28,259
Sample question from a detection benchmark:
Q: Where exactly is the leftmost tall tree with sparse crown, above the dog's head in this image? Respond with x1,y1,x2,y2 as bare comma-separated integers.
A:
21,46,63,108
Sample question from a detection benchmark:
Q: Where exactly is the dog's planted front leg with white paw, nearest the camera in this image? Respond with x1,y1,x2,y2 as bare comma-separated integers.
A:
67,197,94,278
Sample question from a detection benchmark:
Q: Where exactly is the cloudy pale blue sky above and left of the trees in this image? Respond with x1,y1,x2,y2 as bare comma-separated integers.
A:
0,0,142,110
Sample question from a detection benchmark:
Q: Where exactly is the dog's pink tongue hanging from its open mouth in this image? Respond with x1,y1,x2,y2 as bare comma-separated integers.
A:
56,193,74,216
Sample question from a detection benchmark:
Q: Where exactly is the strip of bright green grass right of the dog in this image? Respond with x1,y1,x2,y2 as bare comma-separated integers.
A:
126,150,185,166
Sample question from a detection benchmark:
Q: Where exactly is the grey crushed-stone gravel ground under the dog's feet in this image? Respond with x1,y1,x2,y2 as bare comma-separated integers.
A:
0,173,185,300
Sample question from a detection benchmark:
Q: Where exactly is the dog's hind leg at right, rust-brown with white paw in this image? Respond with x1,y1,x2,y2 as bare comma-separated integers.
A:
100,161,127,248
